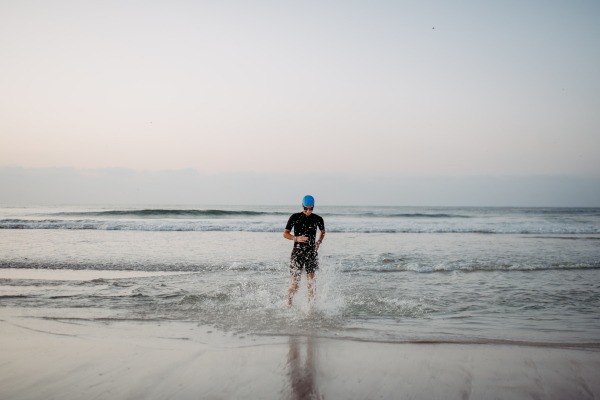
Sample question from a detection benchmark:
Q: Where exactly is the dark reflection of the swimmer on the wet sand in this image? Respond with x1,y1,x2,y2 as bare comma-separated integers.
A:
287,336,320,400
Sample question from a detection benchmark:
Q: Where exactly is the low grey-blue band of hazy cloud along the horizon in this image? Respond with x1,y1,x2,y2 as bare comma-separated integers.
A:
0,167,600,207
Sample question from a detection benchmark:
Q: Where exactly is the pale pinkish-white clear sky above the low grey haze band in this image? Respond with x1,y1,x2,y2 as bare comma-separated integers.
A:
0,0,600,176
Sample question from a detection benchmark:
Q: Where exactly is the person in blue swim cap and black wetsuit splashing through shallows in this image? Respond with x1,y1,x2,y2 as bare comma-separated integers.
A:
283,196,325,306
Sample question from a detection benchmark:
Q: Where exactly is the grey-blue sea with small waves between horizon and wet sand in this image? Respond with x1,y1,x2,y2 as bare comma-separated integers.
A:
0,205,600,346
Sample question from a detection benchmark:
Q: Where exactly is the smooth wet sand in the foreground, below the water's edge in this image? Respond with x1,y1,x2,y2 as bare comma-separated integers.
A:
0,309,600,399
